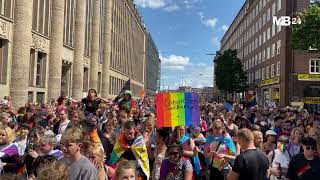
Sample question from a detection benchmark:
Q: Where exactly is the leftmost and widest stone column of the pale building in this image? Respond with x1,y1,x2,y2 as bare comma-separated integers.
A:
10,1,32,108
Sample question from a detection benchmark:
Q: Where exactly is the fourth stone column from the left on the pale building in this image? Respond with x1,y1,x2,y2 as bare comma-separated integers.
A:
89,0,100,89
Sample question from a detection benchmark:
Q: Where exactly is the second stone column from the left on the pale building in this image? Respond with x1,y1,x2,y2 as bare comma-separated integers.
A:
48,0,64,100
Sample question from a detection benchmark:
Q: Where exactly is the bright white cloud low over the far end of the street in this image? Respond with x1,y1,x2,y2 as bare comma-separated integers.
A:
160,54,190,70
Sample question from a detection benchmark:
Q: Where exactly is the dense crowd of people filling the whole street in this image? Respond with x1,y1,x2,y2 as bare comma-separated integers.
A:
0,89,320,180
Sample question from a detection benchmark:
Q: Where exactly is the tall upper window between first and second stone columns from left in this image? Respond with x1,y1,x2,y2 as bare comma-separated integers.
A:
32,0,51,37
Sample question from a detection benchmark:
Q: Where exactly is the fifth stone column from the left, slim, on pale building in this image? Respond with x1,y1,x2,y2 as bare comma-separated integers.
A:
101,0,113,98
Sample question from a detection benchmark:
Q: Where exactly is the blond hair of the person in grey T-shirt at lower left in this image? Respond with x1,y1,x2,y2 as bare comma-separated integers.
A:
61,127,83,144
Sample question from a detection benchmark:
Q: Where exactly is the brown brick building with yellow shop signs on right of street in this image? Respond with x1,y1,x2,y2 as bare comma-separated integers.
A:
220,0,320,111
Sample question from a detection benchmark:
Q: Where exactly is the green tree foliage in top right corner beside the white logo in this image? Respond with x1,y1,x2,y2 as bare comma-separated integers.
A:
292,3,320,50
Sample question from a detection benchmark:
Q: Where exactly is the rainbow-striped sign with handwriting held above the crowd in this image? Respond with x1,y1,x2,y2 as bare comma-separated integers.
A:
156,92,200,128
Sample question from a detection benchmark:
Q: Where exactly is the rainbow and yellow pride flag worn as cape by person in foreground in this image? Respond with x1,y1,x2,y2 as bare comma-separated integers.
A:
109,133,150,179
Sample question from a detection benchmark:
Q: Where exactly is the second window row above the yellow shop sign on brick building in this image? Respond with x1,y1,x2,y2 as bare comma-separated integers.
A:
243,40,281,71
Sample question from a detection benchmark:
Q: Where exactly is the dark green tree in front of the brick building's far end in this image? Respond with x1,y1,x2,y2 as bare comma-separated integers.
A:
215,49,248,93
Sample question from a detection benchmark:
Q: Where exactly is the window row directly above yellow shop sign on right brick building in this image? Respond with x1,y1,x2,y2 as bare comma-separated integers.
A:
248,61,280,84
